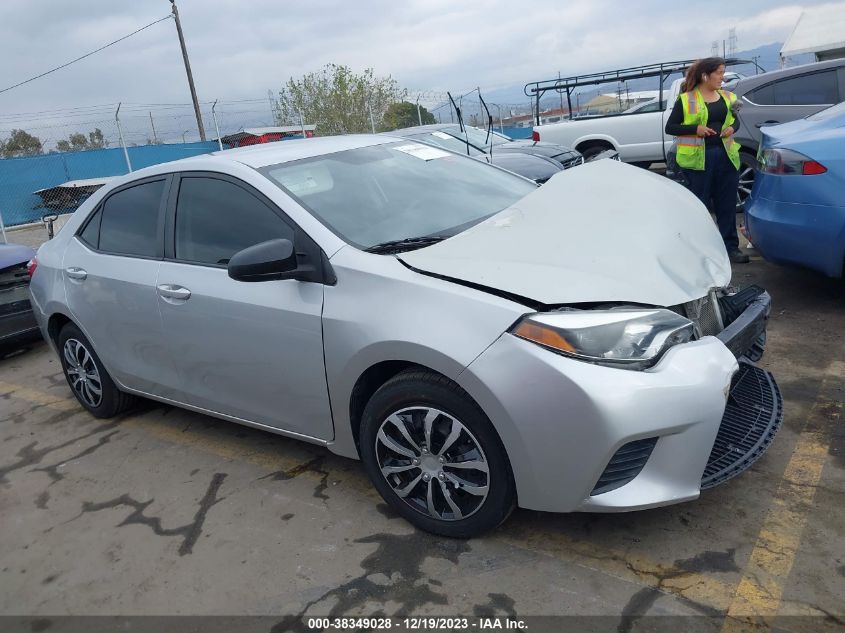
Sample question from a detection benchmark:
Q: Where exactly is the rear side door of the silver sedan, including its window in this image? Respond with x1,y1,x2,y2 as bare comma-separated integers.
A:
63,176,179,398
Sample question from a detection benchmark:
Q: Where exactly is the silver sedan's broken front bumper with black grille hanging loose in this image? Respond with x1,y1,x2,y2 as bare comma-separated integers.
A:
461,289,783,512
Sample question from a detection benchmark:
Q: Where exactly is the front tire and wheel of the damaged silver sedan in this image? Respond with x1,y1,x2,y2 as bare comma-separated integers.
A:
360,370,516,538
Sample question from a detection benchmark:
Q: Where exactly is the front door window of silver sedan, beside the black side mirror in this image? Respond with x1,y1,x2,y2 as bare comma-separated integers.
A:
175,176,294,266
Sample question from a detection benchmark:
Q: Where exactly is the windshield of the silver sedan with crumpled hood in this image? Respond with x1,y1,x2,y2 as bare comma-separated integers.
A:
260,140,536,249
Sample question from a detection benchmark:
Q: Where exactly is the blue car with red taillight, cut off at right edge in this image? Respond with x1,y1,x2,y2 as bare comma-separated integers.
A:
745,102,845,277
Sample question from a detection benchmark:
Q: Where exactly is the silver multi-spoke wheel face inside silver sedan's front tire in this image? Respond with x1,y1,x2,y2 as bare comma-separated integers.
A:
375,407,490,521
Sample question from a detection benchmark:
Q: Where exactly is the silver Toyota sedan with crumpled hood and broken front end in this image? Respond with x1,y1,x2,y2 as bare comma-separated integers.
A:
31,136,781,537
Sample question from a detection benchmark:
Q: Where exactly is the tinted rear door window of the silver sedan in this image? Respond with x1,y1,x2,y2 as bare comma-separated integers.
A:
98,180,165,257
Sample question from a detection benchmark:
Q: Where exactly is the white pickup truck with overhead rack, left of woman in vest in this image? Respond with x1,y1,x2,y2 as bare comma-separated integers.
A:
534,79,683,167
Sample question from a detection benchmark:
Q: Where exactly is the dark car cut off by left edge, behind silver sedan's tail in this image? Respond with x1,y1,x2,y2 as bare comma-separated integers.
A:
0,244,41,355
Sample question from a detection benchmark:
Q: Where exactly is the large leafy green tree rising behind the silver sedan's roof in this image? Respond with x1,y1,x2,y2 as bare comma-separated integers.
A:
274,64,407,136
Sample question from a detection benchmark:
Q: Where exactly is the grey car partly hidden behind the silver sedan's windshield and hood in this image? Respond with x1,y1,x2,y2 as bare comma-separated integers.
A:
387,126,564,185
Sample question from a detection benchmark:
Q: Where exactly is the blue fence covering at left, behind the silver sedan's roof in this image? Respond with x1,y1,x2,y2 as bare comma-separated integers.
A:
0,141,218,226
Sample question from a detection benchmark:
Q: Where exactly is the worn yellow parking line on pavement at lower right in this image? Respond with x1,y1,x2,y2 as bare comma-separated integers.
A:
722,361,845,632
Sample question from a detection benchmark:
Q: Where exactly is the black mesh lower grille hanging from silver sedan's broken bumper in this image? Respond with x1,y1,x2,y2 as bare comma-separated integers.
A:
701,362,783,489
